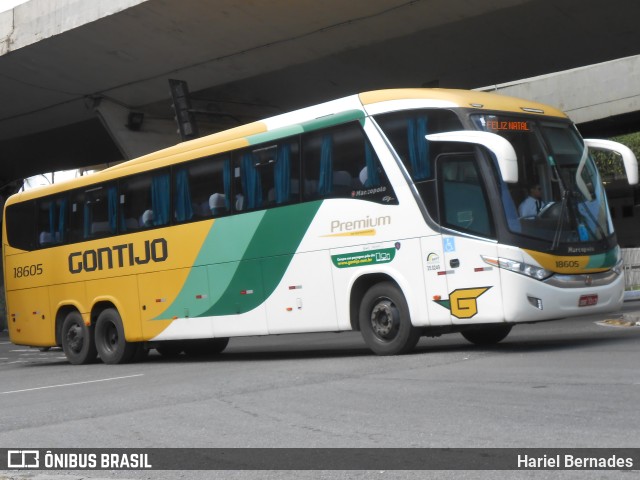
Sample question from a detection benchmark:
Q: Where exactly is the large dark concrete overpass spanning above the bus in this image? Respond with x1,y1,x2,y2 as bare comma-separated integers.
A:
0,0,640,188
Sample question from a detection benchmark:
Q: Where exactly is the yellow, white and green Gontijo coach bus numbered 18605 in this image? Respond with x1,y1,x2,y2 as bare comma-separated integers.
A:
3,89,638,364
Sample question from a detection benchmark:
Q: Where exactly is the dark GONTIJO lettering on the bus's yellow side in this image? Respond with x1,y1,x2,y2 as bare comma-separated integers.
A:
69,238,169,273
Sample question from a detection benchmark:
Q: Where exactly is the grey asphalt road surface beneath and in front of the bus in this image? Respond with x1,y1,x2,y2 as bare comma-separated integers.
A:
0,301,640,479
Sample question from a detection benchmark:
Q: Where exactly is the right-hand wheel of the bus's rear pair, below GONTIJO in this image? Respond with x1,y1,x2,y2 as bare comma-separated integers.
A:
95,308,138,364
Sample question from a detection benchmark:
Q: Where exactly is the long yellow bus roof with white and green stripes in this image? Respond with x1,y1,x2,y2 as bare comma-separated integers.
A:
7,88,567,204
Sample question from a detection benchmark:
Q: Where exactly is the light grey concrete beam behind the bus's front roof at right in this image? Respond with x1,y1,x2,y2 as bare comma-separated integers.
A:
478,55,640,124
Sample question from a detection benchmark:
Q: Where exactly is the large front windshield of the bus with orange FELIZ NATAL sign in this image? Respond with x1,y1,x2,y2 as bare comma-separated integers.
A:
471,114,613,246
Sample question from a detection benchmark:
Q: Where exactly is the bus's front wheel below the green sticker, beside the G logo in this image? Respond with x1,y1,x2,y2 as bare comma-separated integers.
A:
359,282,421,355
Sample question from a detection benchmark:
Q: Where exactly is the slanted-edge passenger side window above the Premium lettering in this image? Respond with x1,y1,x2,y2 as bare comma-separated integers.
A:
302,122,397,203
